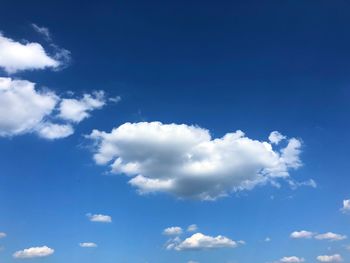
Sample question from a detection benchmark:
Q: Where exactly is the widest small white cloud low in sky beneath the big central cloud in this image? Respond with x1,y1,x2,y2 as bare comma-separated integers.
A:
166,233,242,251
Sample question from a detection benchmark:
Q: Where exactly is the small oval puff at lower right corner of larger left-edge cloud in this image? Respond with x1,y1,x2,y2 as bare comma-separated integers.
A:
37,122,74,140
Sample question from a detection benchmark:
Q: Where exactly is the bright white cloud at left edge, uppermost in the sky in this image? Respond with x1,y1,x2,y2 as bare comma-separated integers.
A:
0,33,61,73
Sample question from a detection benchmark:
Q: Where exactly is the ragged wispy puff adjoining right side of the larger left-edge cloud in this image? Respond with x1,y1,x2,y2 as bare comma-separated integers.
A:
59,91,106,123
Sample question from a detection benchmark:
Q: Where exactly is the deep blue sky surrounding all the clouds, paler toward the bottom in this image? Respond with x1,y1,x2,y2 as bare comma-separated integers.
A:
0,0,350,263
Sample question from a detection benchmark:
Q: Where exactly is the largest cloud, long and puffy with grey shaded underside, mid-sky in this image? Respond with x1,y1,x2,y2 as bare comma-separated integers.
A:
88,122,302,200
